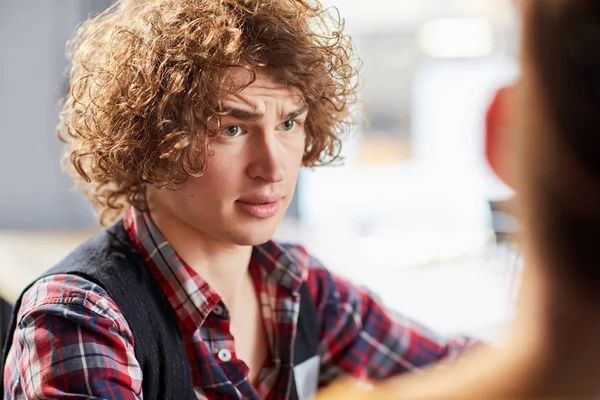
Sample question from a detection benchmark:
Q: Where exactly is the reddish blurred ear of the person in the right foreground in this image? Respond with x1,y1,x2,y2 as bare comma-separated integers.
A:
485,86,514,188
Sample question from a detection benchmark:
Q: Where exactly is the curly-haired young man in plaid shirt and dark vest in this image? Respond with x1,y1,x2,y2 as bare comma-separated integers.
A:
4,0,476,399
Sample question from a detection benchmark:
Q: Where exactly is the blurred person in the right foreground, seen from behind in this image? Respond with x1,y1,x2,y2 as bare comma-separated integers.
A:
318,0,600,400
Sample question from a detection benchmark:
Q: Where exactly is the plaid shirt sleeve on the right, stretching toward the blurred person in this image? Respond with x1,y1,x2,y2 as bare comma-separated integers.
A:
308,252,477,386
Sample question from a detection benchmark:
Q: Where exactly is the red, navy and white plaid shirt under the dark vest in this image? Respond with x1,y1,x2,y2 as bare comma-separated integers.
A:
4,211,472,400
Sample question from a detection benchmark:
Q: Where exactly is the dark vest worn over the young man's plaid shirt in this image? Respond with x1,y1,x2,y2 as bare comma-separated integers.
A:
0,222,320,400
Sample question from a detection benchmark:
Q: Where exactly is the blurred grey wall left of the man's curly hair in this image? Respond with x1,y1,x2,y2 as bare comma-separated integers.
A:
0,0,109,229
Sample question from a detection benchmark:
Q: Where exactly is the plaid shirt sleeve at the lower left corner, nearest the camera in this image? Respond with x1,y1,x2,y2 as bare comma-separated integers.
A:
4,274,142,399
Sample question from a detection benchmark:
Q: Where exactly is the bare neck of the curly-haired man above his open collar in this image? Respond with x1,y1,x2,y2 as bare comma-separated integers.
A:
151,212,252,307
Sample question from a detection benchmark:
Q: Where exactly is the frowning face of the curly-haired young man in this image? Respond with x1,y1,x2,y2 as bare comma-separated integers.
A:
148,72,307,245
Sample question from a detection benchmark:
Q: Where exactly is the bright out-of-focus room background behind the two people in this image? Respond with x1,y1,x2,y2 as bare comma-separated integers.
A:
0,0,519,340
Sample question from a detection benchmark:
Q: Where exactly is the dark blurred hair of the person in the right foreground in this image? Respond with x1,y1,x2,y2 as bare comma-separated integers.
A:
520,0,600,295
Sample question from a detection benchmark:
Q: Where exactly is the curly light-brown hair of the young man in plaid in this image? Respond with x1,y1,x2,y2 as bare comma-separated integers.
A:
57,0,359,225
